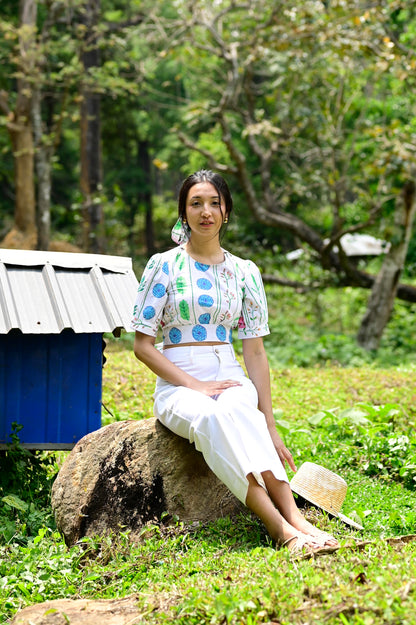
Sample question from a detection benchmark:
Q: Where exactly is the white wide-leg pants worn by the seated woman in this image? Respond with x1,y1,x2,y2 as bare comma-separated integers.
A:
154,344,288,504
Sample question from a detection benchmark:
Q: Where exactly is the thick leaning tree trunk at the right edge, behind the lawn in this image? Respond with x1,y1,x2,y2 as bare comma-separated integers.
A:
357,180,416,351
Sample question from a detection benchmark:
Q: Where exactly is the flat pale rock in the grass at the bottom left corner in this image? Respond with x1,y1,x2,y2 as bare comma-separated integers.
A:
10,596,141,625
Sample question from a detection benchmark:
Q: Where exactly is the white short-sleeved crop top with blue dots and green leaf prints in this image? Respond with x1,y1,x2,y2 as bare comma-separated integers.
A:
131,246,269,345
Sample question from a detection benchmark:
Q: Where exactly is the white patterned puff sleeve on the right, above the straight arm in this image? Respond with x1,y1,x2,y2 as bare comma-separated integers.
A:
237,260,270,339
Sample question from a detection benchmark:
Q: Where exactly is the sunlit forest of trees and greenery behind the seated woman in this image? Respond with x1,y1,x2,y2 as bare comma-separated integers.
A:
0,0,416,365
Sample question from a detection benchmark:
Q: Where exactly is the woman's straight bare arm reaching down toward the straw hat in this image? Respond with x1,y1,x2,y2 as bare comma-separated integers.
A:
242,337,296,471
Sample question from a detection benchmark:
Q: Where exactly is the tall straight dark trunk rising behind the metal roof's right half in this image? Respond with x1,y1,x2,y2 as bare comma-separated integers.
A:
80,0,105,254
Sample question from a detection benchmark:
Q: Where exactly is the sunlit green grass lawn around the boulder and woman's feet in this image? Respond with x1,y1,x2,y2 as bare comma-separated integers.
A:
0,342,416,625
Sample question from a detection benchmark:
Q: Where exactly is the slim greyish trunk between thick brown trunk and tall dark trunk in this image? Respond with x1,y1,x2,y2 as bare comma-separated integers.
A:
32,88,53,250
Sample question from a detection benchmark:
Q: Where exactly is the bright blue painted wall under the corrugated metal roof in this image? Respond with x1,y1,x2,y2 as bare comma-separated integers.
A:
0,330,102,448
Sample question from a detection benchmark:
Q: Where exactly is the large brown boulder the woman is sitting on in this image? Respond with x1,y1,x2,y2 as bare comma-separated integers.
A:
52,418,244,545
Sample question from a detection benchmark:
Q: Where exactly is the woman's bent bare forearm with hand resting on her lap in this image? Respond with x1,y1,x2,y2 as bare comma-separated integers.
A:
134,332,239,396
